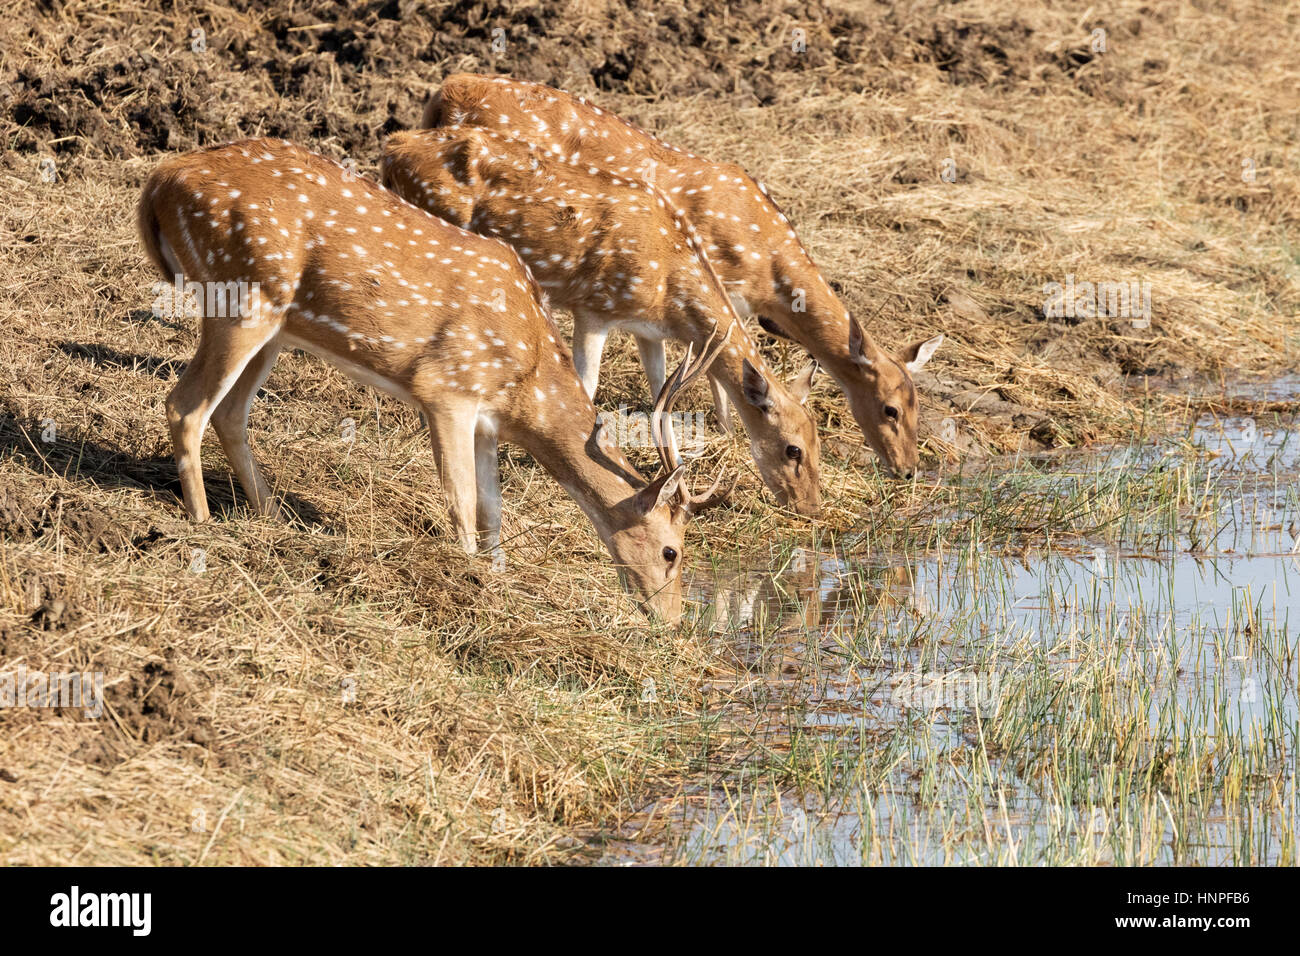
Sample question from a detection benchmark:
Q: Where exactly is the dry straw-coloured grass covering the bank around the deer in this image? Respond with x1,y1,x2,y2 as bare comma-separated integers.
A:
0,1,1300,864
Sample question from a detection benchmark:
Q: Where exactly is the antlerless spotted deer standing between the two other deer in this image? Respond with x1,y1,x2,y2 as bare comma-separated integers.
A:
380,126,822,515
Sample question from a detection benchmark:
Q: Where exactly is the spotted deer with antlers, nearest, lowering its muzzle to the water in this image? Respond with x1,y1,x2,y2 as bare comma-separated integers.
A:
138,139,724,620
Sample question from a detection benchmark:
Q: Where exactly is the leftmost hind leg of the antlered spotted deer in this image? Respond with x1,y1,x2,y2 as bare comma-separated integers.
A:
166,317,280,522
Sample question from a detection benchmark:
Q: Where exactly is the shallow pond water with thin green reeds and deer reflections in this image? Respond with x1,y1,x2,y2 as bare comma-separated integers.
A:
650,395,1300,865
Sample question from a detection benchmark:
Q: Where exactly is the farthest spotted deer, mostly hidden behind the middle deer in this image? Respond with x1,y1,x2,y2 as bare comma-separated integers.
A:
423,74,944,477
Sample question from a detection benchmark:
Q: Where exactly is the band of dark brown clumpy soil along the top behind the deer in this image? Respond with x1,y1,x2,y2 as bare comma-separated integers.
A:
0,0,1091,159
